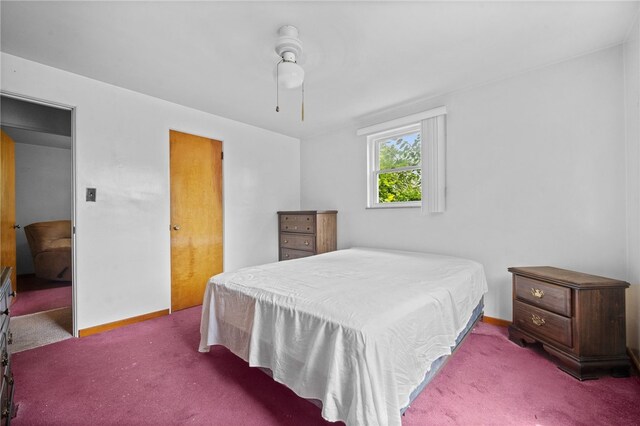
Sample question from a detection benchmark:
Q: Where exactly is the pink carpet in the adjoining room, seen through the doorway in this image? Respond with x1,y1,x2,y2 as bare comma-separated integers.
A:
10,275,71,317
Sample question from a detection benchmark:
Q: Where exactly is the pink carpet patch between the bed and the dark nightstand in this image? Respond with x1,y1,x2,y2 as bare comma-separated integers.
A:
403,323,640,426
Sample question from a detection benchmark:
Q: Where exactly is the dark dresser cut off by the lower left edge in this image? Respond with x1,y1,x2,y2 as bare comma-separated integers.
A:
0,268,15,425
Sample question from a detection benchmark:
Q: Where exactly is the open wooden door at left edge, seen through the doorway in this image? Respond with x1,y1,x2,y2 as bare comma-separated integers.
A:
0,130,16,291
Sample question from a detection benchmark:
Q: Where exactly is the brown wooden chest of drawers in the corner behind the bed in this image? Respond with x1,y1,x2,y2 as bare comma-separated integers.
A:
278,210,338,260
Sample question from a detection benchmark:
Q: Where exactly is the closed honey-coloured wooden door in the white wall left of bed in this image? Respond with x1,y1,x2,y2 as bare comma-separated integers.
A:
169,130,222,311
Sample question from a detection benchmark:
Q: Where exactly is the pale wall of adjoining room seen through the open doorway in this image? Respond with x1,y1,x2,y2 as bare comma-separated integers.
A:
15,143,72,274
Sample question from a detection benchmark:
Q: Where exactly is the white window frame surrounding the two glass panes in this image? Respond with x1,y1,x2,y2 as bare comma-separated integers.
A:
367,121,424,209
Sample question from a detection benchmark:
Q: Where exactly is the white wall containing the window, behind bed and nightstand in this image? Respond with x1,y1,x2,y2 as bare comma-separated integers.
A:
301,47,626,326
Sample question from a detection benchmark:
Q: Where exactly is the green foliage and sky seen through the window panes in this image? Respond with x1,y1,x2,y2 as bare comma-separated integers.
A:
378,133,422,203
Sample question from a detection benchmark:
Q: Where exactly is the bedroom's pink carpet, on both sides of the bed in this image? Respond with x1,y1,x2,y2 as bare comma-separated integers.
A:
12,308,640,426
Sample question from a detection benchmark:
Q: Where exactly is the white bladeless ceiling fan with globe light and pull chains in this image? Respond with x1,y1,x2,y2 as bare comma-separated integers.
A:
275,25,304,121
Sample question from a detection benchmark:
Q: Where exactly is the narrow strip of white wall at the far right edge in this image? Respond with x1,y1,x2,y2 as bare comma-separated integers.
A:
624,14,640,356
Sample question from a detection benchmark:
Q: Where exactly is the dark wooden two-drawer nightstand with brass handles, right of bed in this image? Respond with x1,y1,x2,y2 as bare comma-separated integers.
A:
509,266,630,380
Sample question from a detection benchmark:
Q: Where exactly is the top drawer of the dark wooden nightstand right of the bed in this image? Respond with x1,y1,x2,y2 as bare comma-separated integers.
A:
515,275,571,317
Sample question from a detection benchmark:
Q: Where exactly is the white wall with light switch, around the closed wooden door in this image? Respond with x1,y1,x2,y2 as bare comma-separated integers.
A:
0,53,300,329
